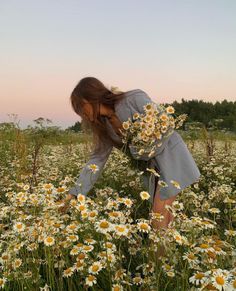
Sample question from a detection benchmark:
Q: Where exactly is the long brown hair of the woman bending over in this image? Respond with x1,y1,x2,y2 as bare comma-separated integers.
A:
70,77,125,153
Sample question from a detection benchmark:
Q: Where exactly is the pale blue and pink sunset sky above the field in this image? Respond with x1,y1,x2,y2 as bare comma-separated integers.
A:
0,0,236,128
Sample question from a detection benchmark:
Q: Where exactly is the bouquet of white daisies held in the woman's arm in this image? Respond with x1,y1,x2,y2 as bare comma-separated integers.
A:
121,102,187,160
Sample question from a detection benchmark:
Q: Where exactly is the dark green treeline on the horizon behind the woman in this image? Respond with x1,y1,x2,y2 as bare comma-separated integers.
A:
68,98,236,132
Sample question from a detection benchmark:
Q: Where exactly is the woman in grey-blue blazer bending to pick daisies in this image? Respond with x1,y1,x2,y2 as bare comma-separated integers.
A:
60,77,200,235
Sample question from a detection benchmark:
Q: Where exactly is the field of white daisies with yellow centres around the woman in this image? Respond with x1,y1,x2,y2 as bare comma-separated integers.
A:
0,124,236,291
